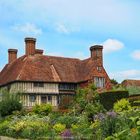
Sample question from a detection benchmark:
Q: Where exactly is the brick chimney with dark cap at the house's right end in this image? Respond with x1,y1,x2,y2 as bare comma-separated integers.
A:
90,45,103,66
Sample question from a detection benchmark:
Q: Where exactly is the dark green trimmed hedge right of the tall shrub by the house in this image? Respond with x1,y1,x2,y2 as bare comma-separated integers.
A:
100,90,129,110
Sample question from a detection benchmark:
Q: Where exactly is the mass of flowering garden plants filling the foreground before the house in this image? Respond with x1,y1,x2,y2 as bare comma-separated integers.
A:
0,85,140,140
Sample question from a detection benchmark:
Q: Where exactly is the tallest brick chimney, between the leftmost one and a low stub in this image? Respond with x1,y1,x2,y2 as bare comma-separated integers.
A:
25,37,36,56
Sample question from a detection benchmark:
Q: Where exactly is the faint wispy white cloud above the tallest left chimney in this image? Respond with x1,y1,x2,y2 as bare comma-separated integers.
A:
12,23,42,35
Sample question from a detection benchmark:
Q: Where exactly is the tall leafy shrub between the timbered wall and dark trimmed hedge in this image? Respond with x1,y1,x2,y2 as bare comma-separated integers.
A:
74,84,104,118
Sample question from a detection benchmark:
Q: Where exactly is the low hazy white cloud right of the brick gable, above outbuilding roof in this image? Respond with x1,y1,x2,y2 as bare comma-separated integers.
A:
109,69,140,81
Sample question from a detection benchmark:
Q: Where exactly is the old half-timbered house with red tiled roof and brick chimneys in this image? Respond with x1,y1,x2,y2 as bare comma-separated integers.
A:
0,38,111,107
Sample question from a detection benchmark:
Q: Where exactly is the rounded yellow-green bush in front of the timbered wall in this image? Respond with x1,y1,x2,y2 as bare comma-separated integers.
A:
33,104,52,115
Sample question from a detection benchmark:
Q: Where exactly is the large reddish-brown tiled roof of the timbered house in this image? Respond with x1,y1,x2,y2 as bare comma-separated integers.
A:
0,55,107,85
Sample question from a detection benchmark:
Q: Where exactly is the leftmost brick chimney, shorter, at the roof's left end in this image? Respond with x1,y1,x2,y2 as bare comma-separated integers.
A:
8,49,18,64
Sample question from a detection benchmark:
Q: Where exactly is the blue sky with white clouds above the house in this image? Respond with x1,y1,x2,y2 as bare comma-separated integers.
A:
0,0,140,82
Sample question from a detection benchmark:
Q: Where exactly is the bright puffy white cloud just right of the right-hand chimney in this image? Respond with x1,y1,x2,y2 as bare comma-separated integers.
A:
102,39,124,53
